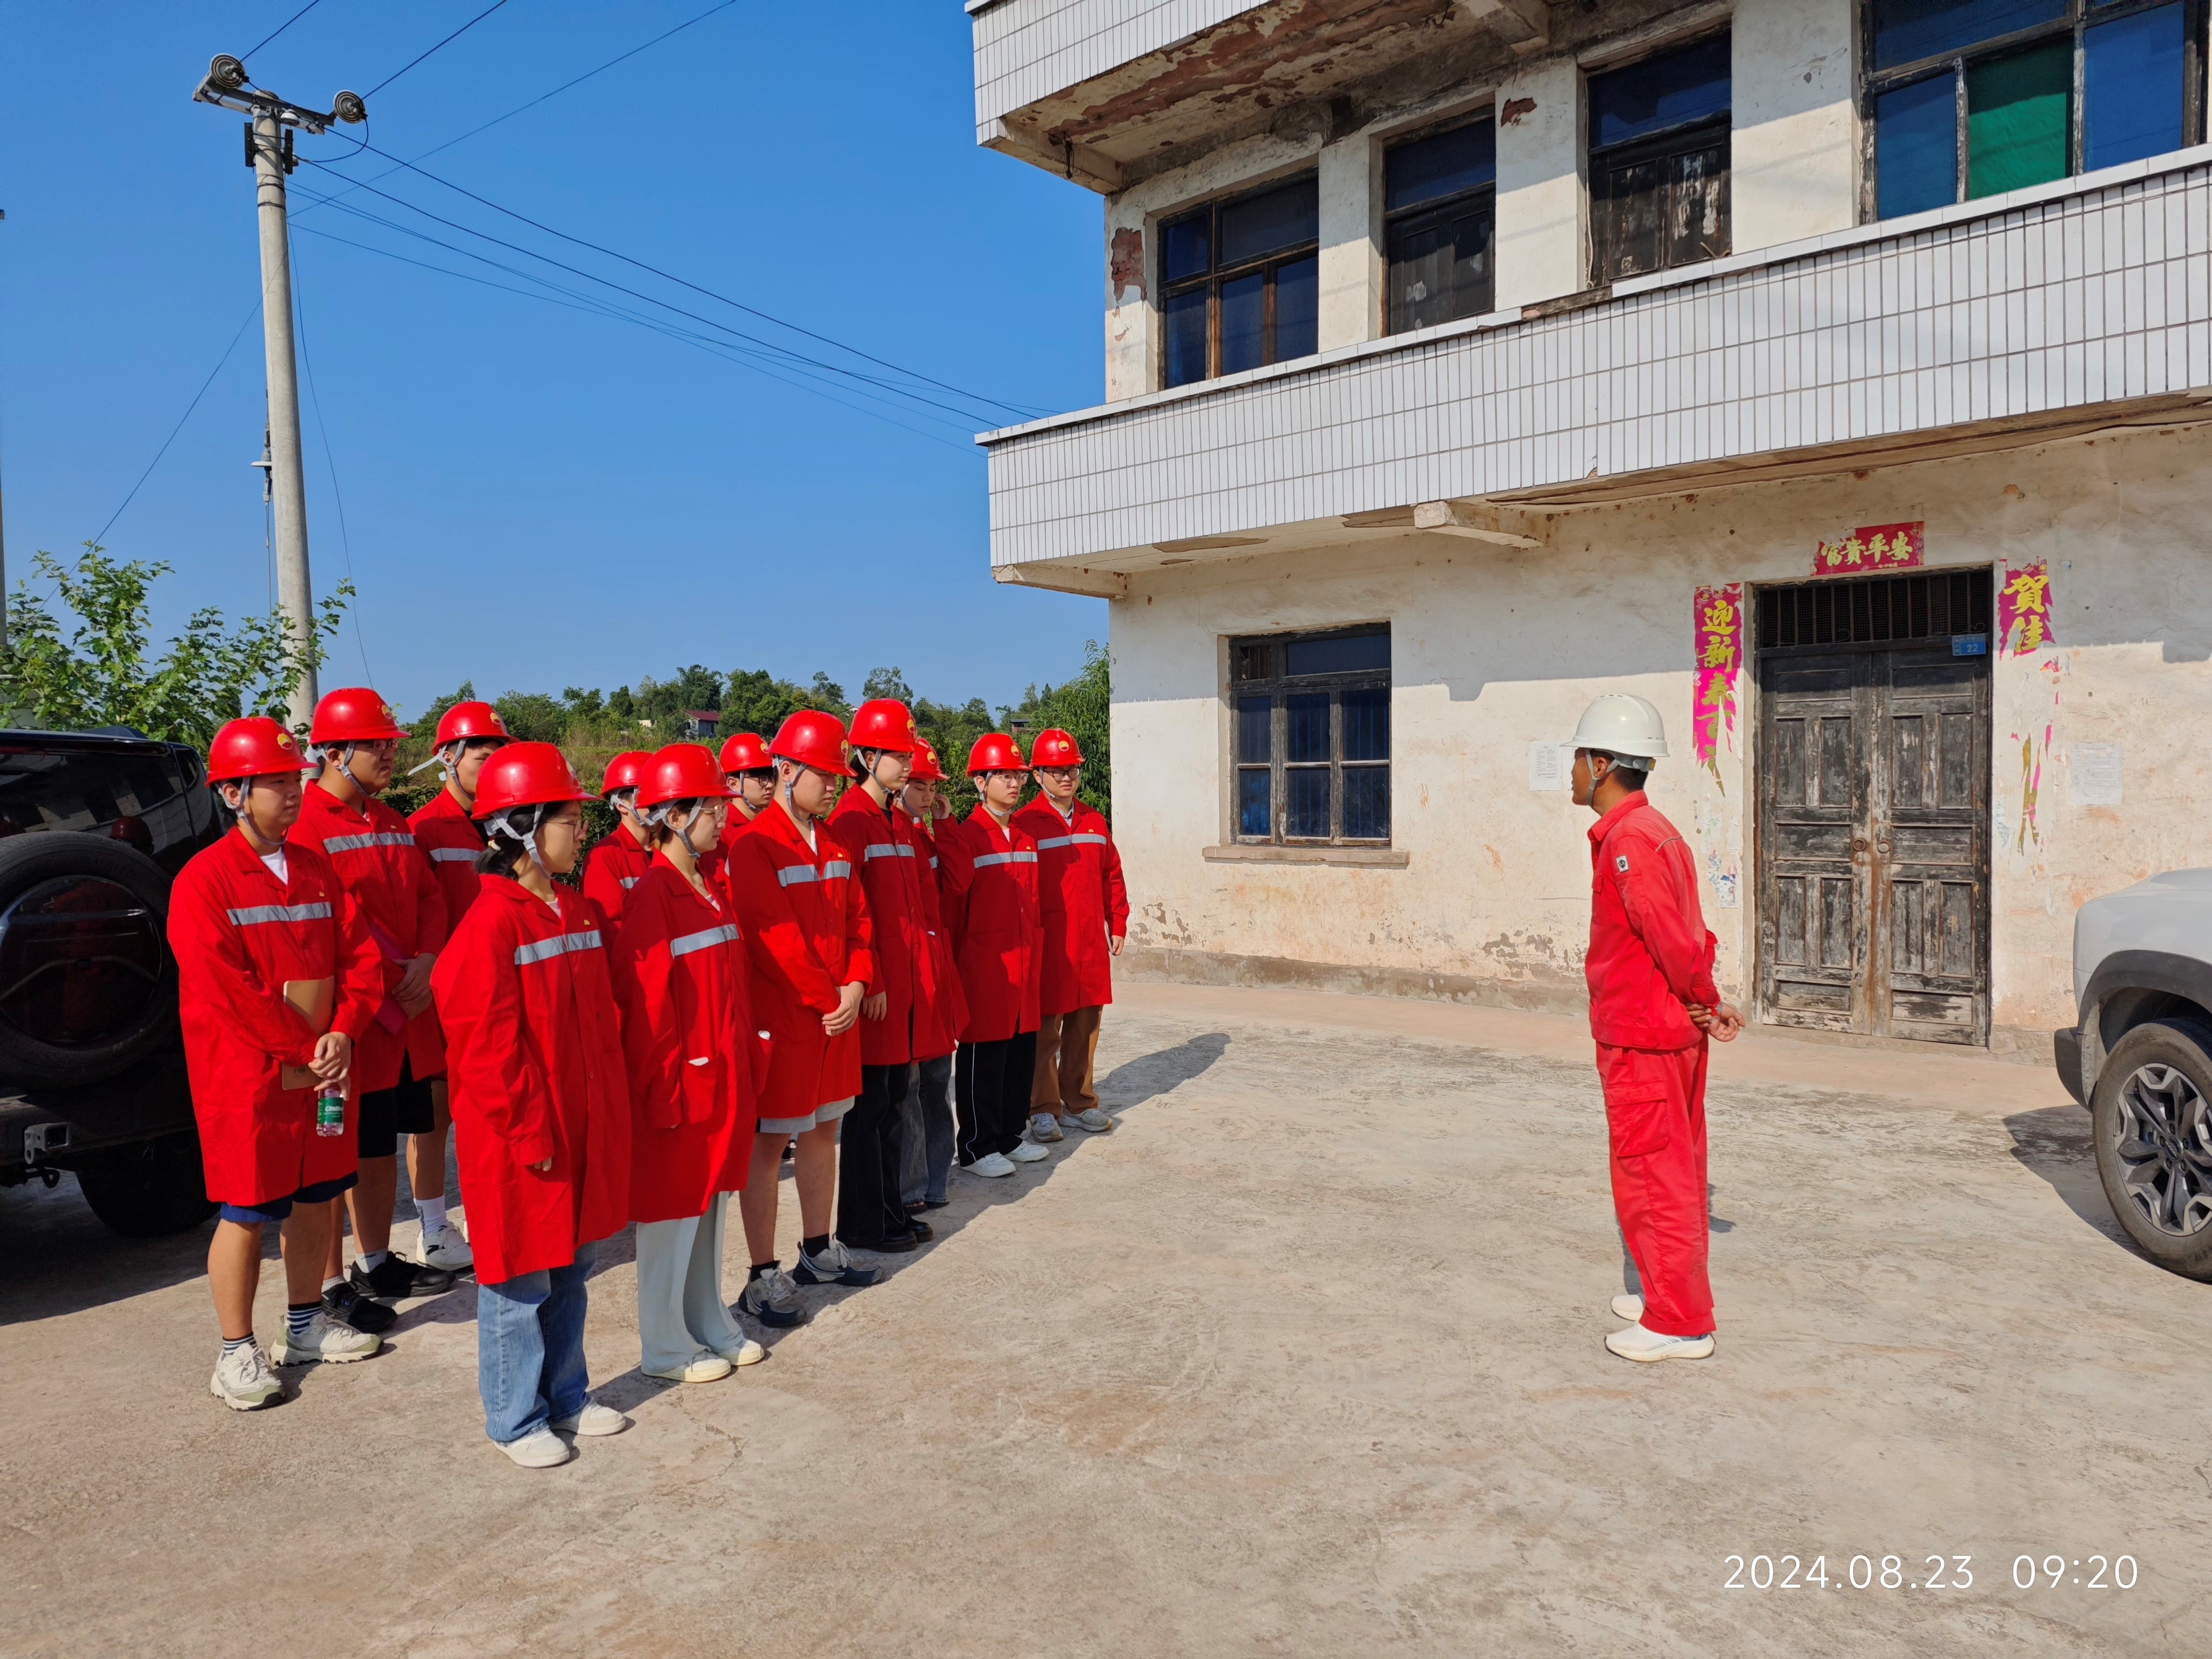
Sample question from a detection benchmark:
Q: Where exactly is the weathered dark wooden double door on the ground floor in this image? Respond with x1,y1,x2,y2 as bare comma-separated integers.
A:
1758,592,1991,1044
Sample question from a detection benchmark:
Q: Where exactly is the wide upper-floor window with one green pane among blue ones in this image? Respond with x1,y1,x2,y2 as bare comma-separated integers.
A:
1863,0,2206,219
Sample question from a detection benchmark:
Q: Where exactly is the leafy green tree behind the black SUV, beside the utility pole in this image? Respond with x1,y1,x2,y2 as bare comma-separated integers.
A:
0,542,354,745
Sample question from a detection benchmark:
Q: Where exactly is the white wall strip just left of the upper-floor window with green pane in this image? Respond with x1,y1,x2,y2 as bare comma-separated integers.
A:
1728,0,1858,254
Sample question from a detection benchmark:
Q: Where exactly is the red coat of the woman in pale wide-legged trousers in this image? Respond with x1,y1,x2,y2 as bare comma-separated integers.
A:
615,858,765,1221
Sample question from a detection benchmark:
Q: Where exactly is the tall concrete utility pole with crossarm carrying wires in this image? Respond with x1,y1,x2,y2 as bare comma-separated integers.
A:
192,53,369,728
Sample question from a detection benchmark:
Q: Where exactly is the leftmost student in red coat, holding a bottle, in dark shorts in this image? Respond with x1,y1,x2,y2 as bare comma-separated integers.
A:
168,719,385,1411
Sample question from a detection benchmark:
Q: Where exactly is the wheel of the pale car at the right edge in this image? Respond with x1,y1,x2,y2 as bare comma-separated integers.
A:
2090,1020,2212,1278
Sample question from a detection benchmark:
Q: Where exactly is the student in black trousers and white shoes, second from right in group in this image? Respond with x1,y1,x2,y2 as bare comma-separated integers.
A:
938,732,1049,1177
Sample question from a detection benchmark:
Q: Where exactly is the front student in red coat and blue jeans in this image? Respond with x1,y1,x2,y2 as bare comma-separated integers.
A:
431,743,630,1469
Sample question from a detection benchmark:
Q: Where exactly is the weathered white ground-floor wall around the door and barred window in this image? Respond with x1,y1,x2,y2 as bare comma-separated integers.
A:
1112,427,2212,1053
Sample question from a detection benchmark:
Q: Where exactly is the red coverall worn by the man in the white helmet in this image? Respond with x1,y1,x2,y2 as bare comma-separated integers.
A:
1584,790,1721,1336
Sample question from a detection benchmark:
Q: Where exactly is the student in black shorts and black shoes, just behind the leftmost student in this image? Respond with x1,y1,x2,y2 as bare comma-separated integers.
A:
292,686,455,1332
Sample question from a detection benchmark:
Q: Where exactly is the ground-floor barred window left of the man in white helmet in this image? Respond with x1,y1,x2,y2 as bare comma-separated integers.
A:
1230,626,1389,845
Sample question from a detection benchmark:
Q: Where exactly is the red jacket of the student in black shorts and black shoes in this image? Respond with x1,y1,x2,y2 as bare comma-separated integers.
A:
285,783,447,1095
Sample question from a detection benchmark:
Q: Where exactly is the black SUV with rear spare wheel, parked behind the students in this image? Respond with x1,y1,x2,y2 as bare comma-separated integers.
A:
0,728,230,1237
